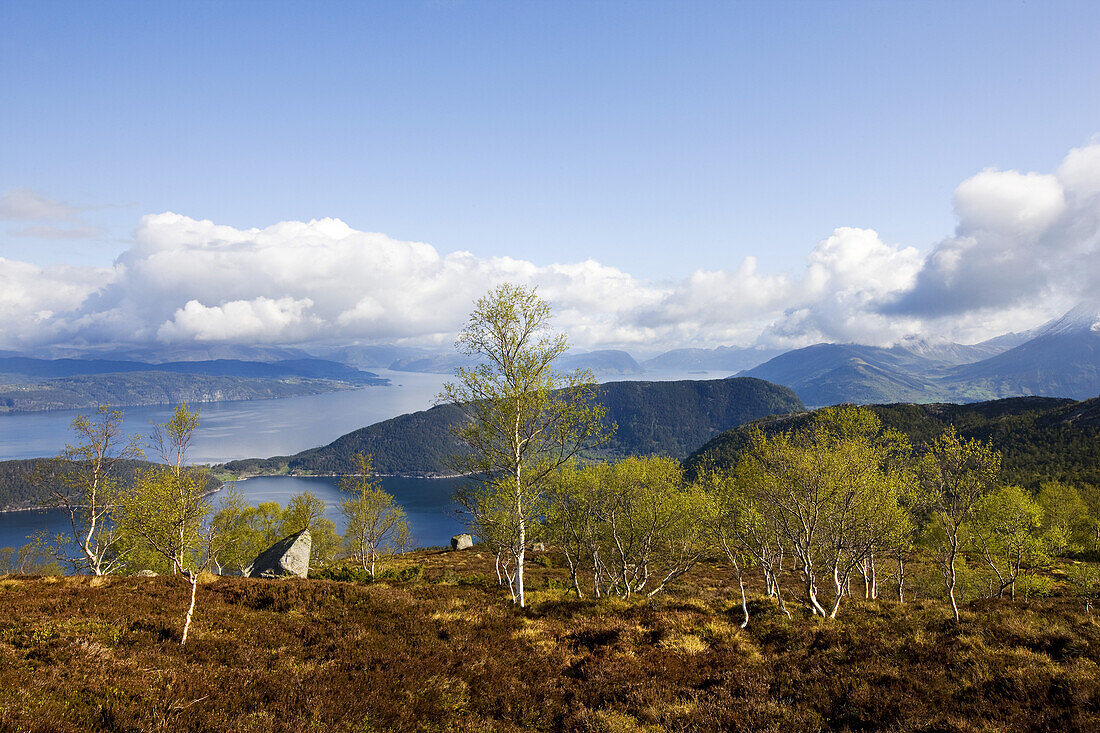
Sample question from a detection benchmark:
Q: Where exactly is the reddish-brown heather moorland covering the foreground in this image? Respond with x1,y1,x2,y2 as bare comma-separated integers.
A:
0,551,1100,733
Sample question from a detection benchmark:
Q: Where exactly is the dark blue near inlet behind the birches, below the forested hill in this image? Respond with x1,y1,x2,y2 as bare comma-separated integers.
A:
0,475,466,547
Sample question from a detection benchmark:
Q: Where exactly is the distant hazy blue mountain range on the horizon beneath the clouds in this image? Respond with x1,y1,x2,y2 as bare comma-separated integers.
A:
8,303,1100,409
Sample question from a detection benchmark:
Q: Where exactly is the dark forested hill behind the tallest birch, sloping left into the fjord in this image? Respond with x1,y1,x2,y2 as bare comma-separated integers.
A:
224,378,804,475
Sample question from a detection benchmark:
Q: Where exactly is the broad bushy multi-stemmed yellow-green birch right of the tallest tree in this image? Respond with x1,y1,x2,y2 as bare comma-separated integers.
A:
702,406,913,623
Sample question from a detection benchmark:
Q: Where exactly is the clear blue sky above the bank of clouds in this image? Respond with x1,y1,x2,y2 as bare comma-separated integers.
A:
0,1,1100,352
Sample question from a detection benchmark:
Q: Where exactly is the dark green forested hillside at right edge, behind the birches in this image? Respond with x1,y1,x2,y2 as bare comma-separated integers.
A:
685,397,1100,488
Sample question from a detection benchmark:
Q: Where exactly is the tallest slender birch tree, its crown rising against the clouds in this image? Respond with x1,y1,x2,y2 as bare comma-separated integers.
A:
439,283,604,606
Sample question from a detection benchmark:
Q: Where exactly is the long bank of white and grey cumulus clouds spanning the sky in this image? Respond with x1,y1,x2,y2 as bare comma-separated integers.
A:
0,138,1100,351
